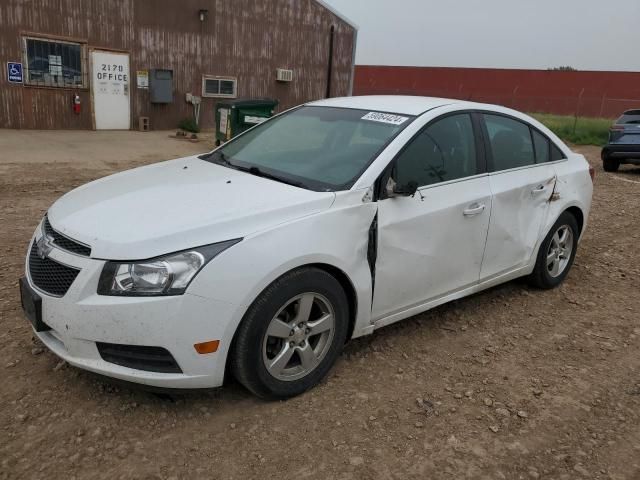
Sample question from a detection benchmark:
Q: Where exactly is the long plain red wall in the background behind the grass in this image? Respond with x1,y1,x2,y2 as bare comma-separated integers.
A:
354,66,640,118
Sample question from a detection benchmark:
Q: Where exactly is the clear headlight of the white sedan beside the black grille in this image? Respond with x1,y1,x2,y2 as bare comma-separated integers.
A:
98,239,242,297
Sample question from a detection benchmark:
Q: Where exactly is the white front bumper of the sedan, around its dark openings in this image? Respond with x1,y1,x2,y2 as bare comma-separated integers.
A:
26,232,237,388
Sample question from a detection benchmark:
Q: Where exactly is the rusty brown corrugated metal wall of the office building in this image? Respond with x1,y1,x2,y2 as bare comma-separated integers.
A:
0,0,355,129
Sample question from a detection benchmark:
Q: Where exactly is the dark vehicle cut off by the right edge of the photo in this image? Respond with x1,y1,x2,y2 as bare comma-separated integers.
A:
602,110,640,172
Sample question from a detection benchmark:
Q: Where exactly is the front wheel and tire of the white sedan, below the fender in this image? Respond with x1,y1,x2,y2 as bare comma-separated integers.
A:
231,267,349,399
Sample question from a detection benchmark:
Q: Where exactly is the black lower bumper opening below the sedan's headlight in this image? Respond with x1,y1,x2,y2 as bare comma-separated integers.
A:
96,342,182,373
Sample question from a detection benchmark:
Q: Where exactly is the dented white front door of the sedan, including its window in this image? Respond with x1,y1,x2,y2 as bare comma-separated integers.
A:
372,113,491,321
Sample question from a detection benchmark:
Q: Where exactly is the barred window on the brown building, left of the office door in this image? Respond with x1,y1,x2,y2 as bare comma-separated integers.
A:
24,38,86,88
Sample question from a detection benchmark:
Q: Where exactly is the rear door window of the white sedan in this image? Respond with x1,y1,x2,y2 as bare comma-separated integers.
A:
483,114,536,172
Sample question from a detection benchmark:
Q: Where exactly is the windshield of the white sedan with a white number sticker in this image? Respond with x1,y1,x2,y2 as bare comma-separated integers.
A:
200,106,413,191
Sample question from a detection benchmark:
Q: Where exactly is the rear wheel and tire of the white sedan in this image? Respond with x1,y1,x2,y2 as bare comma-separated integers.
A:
529,212,580,289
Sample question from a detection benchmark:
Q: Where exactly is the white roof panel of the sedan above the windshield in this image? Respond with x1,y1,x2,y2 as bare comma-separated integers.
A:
307,95,479,115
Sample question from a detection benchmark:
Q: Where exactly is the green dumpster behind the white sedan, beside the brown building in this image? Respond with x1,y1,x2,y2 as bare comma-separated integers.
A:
216,98,278,145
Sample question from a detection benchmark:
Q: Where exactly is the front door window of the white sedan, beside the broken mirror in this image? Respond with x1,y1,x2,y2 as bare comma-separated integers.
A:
393,113,477,187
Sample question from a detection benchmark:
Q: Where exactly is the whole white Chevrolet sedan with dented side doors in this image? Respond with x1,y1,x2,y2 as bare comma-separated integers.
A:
21,96,593,398
